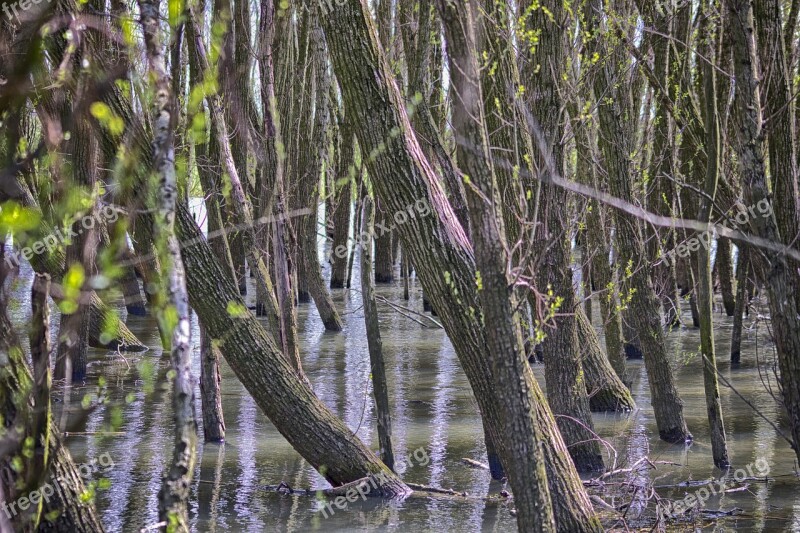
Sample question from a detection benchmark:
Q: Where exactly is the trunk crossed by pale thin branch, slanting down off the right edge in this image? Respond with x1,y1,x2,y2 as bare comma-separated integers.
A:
728,0,800,459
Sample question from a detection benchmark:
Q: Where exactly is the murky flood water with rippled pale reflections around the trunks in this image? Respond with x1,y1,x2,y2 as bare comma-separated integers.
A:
10,229,800,532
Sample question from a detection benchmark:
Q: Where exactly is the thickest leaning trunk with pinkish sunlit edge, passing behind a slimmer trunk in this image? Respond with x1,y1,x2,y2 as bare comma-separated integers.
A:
321,0,600,531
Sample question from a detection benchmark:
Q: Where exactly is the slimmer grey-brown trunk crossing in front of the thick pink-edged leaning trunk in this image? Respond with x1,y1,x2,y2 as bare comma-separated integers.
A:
437,0,560,532
